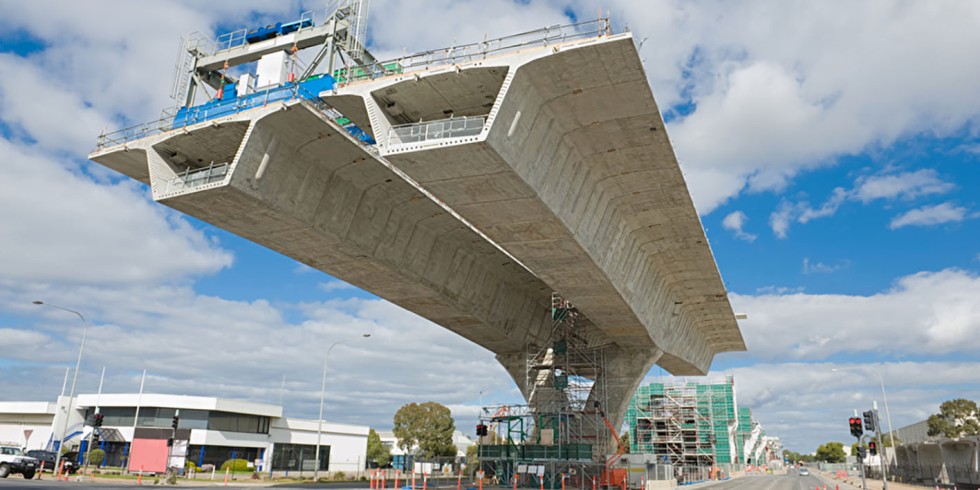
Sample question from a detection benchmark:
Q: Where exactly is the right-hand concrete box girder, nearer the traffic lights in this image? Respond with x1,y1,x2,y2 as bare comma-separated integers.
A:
375,33,744,375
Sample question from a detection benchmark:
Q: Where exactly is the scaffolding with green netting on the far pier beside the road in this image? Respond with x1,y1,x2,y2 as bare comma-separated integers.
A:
626,376,740,471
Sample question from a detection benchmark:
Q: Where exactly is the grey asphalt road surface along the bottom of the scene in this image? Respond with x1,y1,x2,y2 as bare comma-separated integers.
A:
0,470,833,490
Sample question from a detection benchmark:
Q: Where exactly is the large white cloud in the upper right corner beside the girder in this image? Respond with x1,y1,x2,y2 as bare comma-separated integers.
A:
600,0,980,214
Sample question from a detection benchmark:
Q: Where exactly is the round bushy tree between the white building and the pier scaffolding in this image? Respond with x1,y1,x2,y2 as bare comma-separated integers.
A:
392,402,456,458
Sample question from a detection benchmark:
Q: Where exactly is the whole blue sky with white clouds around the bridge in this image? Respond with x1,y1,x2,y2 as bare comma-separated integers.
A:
0,0,980,451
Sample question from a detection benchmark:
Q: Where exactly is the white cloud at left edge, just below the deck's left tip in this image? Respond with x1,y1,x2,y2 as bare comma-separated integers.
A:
0,138,232,283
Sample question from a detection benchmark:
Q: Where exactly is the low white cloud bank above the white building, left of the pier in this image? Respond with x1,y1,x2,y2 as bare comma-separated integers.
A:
0,280,515,426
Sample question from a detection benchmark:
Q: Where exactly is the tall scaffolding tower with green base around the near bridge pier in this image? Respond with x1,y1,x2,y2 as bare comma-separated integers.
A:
479,294,613,489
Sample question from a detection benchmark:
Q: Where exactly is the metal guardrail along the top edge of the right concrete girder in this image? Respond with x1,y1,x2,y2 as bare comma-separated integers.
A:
346,18,612,83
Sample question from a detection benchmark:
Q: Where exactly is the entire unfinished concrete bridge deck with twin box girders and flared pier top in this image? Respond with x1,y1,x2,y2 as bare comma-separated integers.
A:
90,21,745,430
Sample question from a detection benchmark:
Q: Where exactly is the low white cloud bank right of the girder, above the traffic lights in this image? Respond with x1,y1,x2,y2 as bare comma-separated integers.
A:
731,269,980,360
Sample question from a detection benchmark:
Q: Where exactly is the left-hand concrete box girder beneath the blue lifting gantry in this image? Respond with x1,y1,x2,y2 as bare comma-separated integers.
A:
92,103,620,353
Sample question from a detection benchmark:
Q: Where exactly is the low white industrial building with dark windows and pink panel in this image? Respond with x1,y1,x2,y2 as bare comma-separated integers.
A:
0,393,369,475
